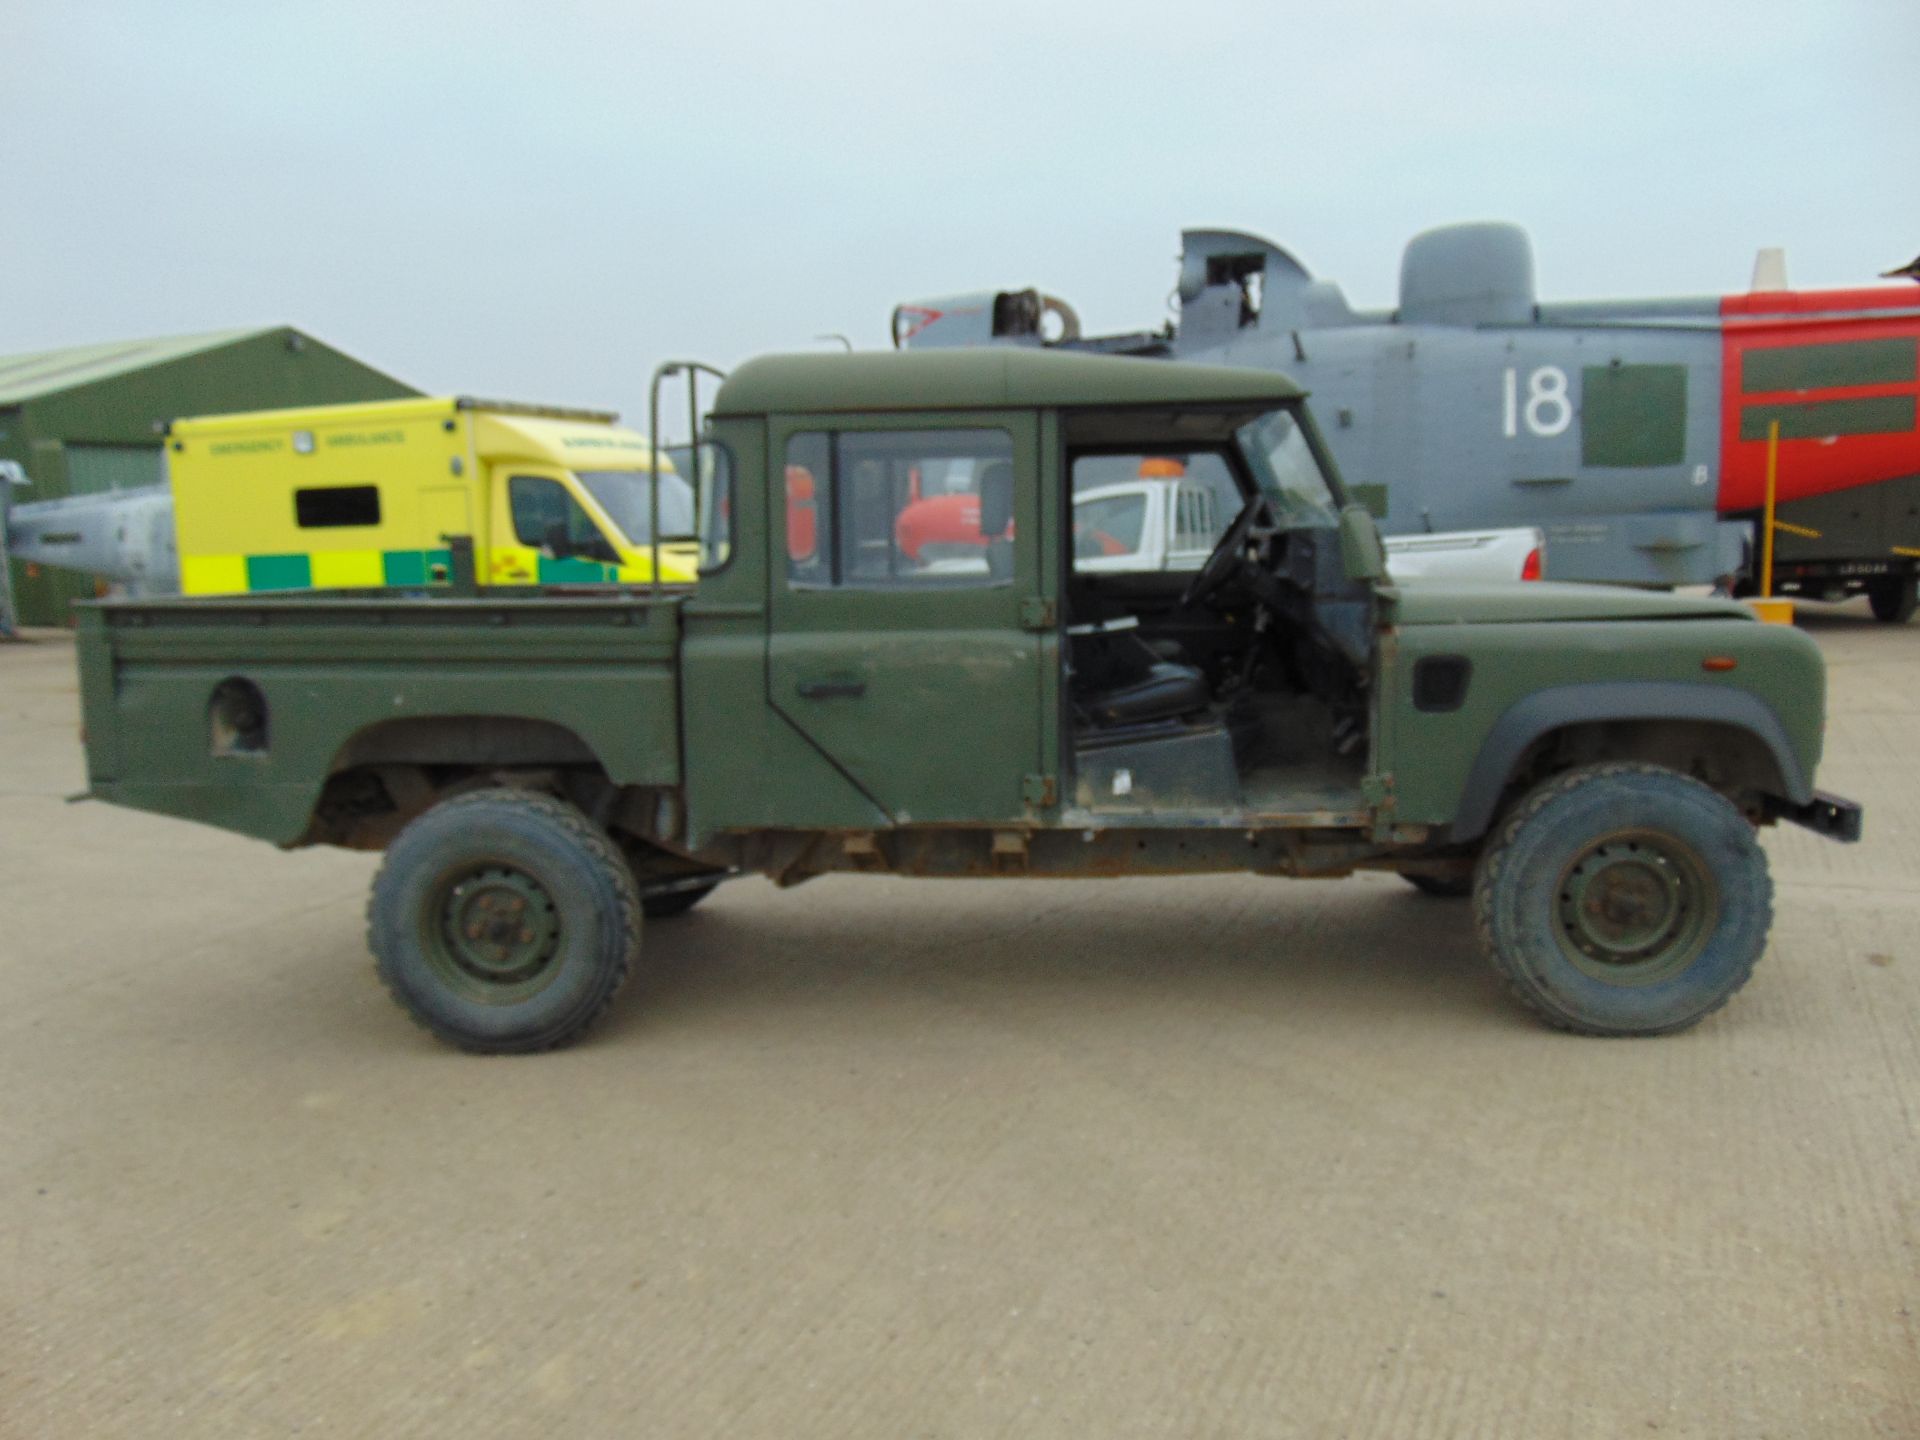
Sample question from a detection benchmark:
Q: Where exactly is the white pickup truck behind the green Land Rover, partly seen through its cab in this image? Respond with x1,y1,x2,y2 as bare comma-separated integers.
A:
1073,476,1546,580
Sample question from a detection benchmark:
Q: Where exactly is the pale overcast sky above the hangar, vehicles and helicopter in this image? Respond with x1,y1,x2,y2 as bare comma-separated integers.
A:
0,0,1920,433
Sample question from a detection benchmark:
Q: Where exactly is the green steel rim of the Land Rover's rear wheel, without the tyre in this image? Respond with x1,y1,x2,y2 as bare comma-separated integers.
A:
420,862,563,1004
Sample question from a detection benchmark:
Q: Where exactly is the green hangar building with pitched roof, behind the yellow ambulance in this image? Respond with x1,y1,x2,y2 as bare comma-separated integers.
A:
0,324,419,626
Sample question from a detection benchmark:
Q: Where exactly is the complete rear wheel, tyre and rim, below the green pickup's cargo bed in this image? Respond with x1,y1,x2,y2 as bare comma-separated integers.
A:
367,789,641,1054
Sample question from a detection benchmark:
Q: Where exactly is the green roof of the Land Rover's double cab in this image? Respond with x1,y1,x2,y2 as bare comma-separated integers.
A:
712,348,1306,415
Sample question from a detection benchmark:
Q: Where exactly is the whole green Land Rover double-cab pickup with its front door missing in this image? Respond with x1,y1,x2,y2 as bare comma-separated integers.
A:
79,349,1860,1050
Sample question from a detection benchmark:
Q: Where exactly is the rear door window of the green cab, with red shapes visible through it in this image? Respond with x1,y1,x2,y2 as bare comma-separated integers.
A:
785,428,1014,589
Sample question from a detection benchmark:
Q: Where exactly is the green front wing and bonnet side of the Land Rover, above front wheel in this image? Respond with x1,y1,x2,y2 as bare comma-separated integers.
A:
1380,618,1826,839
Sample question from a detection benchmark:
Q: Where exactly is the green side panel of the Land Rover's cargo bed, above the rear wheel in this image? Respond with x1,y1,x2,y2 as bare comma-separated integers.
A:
81,595,680,845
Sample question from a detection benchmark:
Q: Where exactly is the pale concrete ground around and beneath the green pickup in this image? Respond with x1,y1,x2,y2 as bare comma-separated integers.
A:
0,607,1920,1440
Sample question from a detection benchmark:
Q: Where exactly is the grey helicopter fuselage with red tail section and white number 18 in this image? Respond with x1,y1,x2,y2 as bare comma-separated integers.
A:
893,225,1920,609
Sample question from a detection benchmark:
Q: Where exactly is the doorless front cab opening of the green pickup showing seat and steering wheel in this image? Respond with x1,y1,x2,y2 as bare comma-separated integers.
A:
1064,403,1384,828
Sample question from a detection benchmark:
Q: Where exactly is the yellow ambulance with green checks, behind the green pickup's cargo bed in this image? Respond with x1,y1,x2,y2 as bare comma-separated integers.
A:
167,397,699,595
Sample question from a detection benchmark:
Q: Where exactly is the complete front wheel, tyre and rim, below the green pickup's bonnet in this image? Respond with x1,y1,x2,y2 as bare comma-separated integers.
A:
1473,762,1772,1035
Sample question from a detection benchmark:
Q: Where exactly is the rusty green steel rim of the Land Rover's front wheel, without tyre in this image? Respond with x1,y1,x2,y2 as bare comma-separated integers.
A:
1553,829,1720,985
